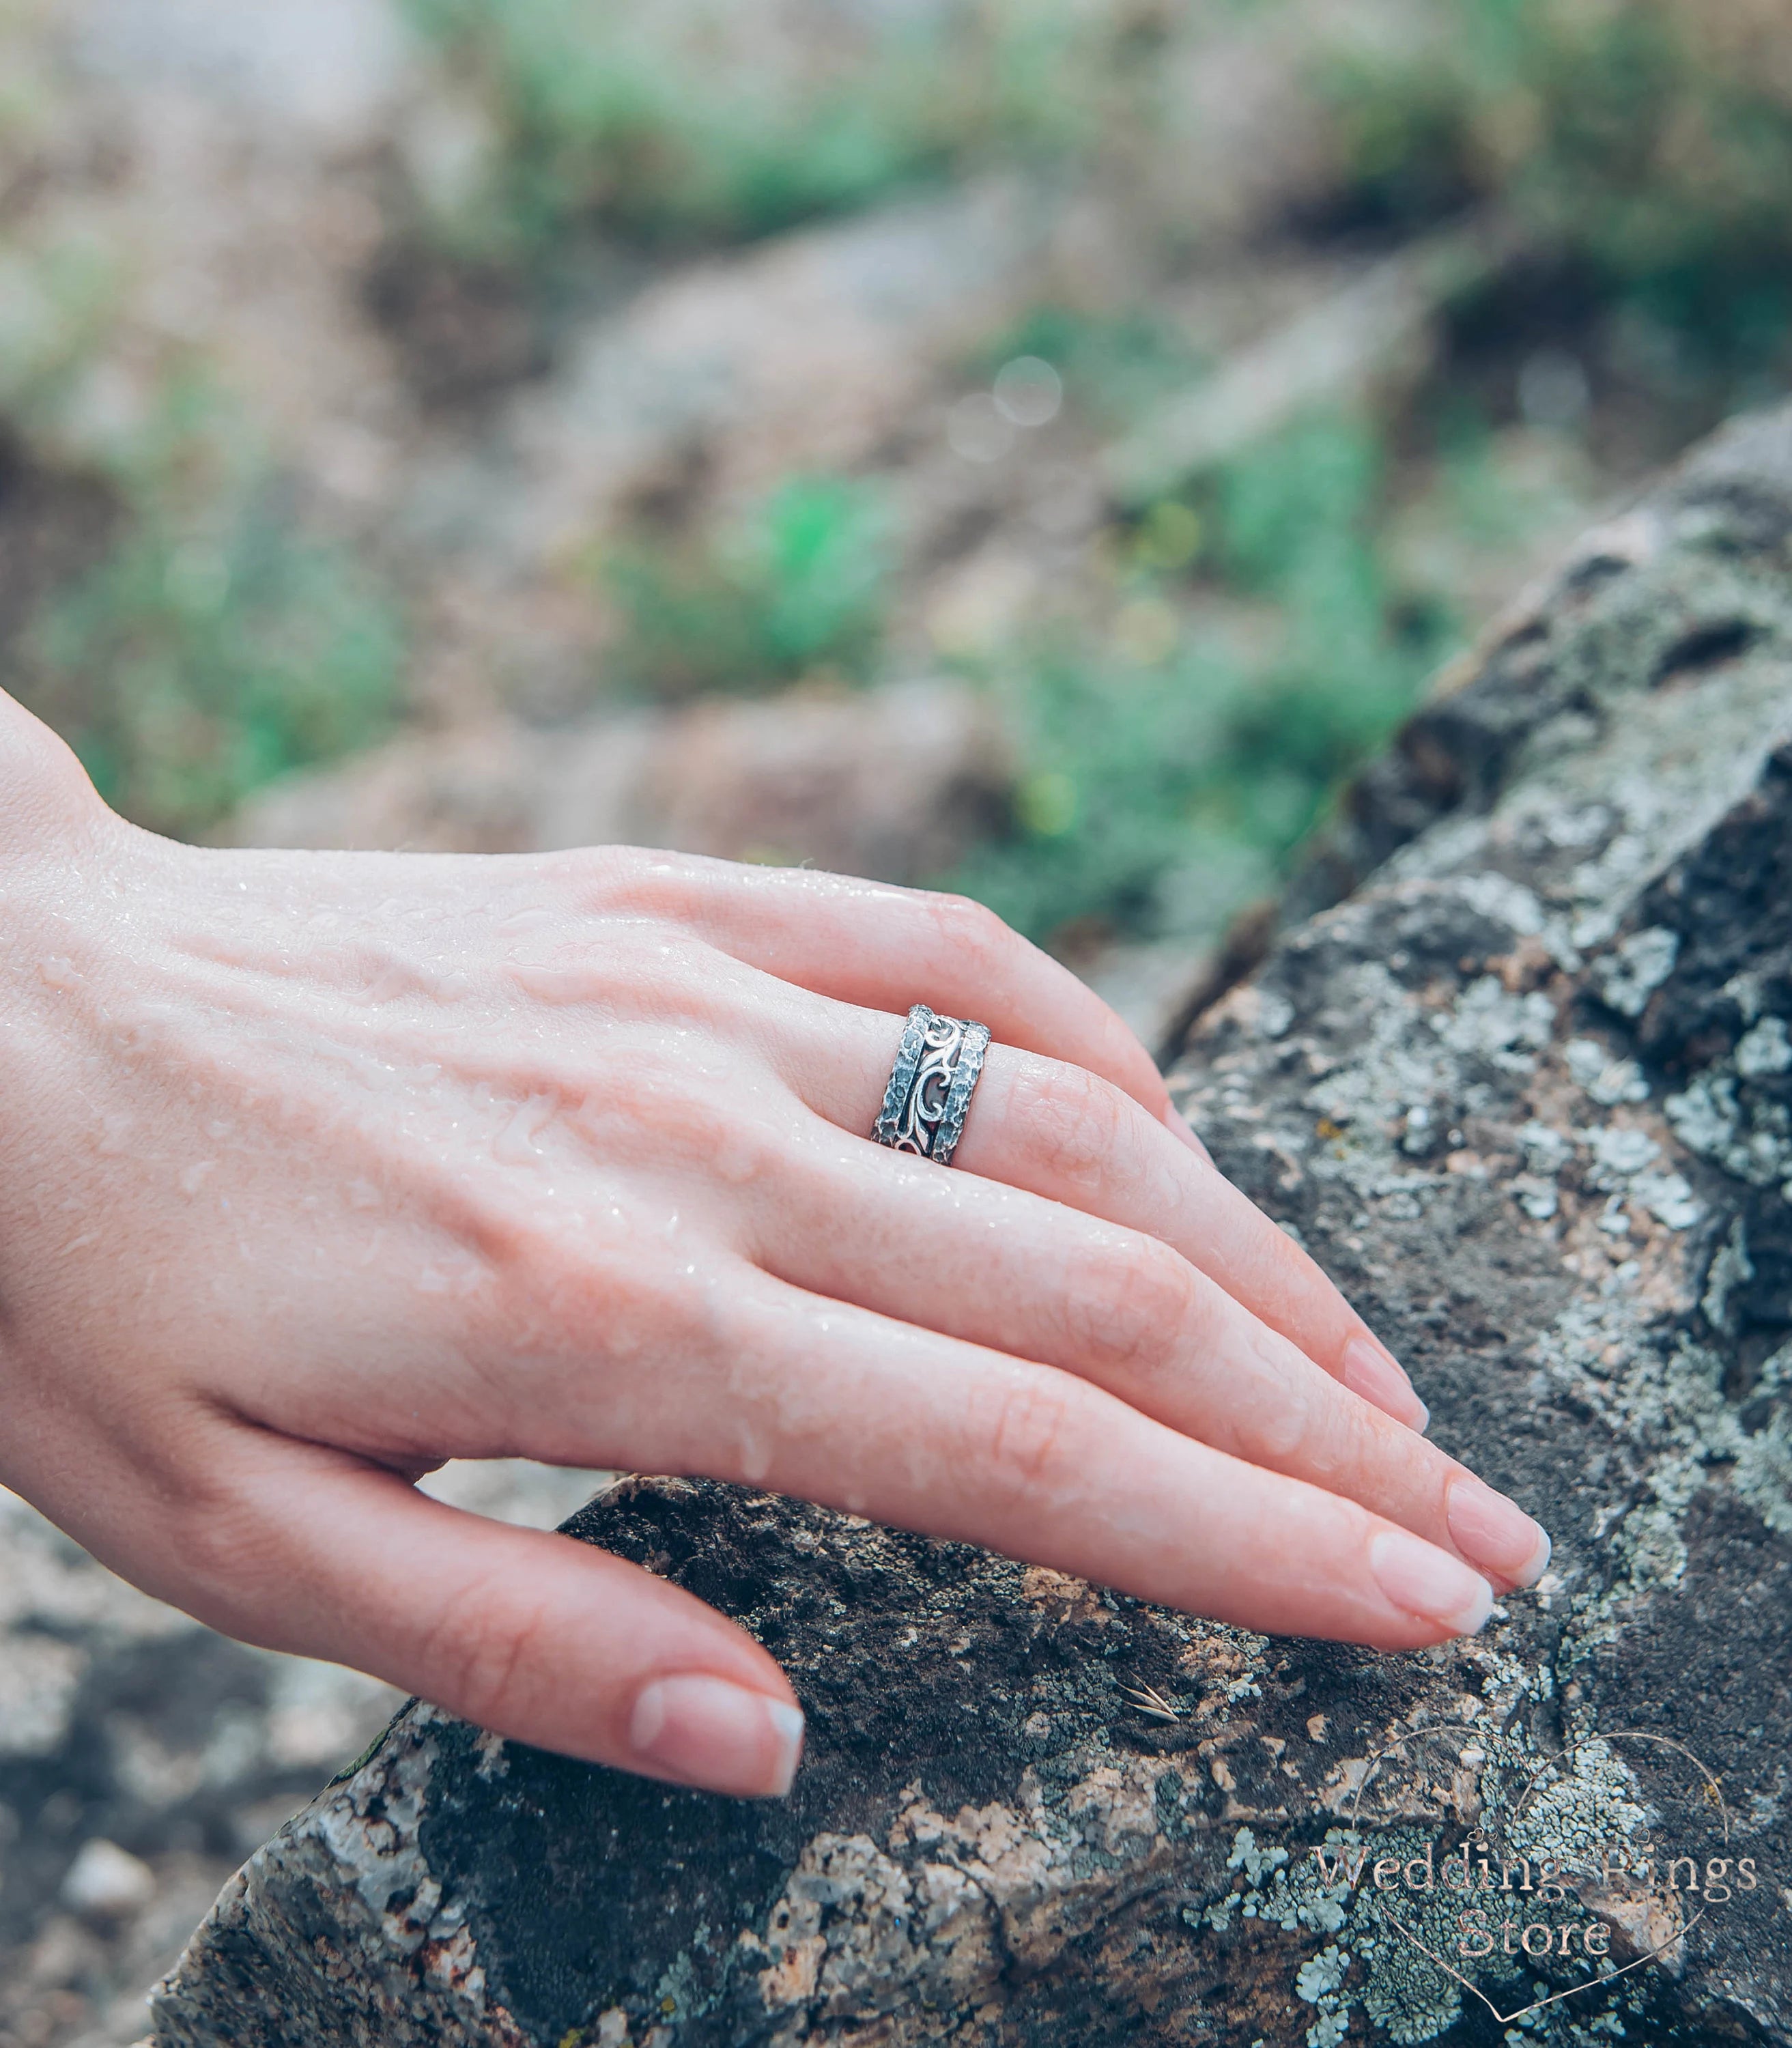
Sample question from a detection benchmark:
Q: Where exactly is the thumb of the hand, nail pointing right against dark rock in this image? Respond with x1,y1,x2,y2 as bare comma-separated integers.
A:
190,1438,803,1798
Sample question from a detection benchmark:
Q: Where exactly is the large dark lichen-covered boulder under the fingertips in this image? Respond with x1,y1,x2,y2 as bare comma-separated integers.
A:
154,412,1792,2048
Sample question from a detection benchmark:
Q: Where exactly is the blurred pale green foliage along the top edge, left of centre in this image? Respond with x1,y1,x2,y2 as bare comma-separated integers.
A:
406,0,1151,256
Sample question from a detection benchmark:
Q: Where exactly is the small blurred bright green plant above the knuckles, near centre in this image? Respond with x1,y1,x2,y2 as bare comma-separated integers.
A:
600,477,891,698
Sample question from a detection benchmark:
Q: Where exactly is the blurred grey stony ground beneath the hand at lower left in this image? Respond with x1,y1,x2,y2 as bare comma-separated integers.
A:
0,1460,604,2048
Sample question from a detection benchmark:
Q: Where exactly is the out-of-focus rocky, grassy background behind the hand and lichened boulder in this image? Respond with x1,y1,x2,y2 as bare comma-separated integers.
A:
0,0,1792,2048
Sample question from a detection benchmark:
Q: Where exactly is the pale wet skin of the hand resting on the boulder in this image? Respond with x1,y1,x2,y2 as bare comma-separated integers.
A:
0,696,1548,1796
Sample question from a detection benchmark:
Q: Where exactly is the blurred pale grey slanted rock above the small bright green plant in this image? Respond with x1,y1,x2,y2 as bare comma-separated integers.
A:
434,178,1063,567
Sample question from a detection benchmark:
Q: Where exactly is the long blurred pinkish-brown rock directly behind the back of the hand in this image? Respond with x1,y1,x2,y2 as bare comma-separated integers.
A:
227,682,1012,883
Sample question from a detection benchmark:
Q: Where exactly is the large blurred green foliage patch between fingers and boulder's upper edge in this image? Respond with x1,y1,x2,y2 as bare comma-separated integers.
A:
950,416,1456,940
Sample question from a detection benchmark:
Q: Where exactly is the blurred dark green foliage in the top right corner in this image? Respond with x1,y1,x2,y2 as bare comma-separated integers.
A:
1327,0,1792,381
